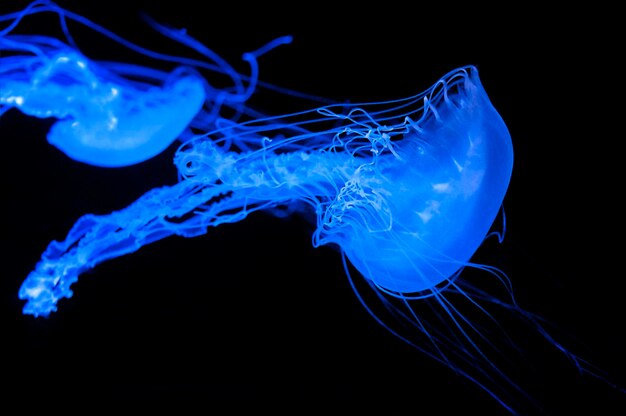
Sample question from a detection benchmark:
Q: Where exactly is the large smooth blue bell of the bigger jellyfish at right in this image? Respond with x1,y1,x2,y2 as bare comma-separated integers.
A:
312,67,513,293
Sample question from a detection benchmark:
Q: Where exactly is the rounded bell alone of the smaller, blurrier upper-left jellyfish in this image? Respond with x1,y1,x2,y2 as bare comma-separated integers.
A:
48,61,205,167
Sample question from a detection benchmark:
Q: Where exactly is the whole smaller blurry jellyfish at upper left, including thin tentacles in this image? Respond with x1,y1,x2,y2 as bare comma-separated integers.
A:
0,0,291,167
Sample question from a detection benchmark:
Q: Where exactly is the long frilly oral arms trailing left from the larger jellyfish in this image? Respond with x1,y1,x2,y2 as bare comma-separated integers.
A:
19,141,342,316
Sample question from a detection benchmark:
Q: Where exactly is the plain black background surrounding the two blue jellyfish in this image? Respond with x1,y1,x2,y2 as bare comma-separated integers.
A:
0,0,626,415
